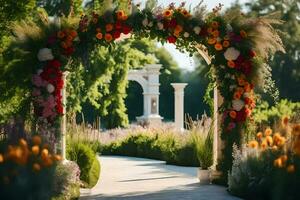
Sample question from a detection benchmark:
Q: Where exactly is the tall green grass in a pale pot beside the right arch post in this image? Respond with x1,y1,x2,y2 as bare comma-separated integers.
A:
191,117,213,185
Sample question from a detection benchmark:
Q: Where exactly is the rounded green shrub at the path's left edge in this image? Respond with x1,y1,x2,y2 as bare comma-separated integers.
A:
67,141,97,185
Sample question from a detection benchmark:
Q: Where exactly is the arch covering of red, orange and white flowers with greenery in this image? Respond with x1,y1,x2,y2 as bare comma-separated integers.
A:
17,2,283,178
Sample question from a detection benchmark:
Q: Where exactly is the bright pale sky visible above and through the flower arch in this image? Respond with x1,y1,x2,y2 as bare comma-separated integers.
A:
133,0,249,71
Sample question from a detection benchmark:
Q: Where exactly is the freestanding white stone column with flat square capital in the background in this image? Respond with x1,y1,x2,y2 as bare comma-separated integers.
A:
171,83,187,131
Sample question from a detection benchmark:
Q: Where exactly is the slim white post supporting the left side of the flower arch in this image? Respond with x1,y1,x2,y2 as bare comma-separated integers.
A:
61,71,69,160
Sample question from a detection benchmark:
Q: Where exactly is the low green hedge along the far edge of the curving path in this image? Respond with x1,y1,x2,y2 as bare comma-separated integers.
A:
98,133,199,166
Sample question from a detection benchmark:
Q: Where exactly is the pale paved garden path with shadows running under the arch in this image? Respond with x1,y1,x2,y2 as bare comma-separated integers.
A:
80,156,238,200
